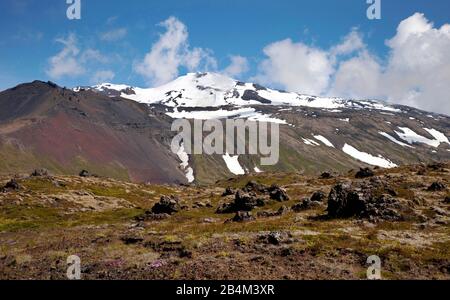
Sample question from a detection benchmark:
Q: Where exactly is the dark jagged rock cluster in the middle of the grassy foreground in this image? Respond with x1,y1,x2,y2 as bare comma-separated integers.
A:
216,181,289,222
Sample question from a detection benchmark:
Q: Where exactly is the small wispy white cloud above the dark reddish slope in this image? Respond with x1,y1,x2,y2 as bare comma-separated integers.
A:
46,34,85,79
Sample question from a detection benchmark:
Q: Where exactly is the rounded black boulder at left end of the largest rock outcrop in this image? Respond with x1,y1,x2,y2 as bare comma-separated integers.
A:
327,184,366,218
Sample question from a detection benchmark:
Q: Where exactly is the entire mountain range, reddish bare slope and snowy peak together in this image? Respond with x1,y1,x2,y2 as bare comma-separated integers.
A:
0,73,450,183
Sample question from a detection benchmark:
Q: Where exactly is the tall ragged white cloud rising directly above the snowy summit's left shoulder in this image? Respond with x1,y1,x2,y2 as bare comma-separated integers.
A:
134,17,217,85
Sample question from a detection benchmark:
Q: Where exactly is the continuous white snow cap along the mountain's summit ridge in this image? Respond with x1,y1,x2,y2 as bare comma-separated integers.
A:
84,73,398,111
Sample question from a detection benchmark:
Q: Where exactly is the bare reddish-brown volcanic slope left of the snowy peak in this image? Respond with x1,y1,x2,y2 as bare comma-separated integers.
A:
0,81,185,183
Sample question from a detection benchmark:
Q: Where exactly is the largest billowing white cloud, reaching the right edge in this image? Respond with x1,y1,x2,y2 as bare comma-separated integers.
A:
331,13,450,114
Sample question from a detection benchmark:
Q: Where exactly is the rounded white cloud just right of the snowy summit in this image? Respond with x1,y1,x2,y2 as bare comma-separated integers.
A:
255,39,333,94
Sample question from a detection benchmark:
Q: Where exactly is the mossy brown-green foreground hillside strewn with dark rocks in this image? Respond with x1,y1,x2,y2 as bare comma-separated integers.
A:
0,163,450,279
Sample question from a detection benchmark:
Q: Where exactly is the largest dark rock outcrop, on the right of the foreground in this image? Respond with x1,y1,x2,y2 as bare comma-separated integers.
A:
327,180,411,221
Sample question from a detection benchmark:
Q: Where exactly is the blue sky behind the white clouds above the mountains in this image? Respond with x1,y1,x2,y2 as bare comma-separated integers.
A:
0,0,450,112
